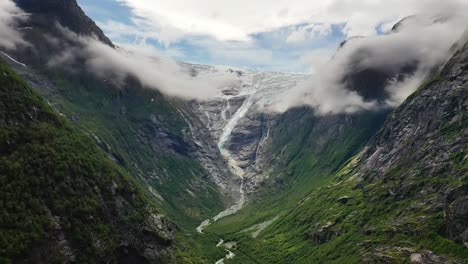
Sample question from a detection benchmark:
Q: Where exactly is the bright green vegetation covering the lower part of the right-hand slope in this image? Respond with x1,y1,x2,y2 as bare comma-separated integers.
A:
222,147,468,263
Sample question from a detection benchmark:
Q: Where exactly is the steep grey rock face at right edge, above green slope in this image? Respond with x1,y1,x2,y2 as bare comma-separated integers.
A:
359,38,468,243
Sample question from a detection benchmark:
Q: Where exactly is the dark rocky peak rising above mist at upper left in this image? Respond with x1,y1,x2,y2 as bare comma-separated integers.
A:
11,0,114,69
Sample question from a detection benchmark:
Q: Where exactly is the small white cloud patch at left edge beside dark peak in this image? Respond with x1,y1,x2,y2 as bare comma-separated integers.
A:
0,0,27,49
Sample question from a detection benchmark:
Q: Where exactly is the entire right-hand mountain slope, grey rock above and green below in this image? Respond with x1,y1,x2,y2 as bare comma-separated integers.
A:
213,37,468,263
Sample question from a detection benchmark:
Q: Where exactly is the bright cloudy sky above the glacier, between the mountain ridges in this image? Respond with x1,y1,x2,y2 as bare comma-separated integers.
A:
78,0,466,73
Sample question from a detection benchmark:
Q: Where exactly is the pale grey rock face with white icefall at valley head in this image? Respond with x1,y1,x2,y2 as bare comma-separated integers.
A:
187,65,307,199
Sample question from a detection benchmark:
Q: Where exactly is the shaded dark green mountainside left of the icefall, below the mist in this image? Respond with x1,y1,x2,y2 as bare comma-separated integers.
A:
44,69,225,232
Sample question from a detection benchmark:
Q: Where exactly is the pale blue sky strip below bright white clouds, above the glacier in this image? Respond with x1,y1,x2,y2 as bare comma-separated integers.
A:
78,0,352,72
